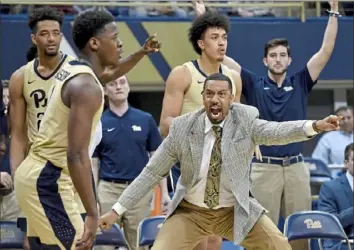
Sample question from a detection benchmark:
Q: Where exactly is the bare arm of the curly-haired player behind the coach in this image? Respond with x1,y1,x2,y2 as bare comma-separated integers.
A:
160,66,192,137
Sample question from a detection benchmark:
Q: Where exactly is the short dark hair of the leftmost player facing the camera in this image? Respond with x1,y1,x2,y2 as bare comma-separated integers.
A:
28,6,63,33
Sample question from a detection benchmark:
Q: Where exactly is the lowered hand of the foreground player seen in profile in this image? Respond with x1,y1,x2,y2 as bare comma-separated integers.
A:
75,215,98,250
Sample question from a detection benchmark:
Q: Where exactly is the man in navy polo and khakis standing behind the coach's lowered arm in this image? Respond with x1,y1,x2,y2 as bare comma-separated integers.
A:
93,76,170,250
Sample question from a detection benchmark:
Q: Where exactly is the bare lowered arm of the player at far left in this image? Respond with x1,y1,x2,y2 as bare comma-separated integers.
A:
9,68,28,177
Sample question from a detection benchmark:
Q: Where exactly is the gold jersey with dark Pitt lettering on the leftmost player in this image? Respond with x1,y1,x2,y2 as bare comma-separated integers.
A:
23,54,74,146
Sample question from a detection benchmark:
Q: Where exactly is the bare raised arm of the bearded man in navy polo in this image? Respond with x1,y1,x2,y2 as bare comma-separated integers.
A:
307,0,338,81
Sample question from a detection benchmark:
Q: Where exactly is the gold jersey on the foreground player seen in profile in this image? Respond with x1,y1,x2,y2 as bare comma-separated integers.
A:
29,61,104,170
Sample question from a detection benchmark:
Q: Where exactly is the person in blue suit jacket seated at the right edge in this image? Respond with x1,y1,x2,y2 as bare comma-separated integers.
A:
318,143,354,250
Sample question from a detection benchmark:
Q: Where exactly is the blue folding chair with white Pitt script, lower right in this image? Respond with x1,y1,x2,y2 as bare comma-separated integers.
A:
284,211,351,250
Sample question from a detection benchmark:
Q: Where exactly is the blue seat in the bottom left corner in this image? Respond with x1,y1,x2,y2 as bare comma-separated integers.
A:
0,221,25,249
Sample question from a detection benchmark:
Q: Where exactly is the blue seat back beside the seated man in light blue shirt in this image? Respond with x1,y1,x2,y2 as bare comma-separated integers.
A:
304,157,332,182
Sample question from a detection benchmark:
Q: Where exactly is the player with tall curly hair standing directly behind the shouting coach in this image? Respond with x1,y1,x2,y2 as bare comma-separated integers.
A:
160,9,241,250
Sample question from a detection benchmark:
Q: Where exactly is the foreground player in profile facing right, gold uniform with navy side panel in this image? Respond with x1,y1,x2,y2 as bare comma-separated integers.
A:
15,8,159,249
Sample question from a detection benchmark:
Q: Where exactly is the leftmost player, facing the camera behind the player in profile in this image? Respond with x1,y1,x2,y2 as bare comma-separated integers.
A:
9,7,73,249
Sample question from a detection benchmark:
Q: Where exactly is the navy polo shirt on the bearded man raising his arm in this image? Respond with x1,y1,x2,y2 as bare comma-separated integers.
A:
241,67,317,157
